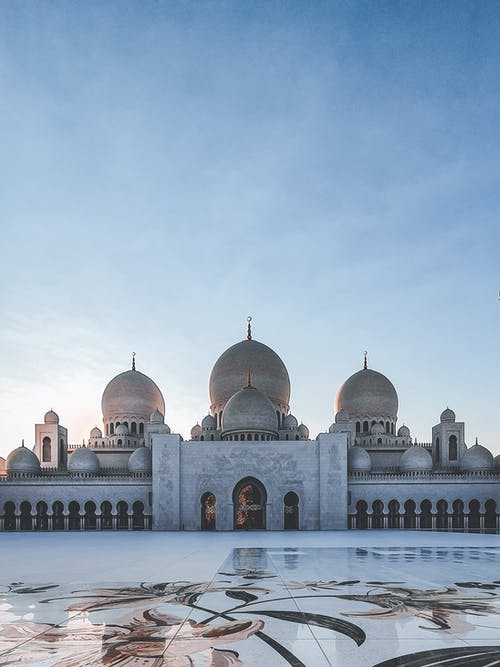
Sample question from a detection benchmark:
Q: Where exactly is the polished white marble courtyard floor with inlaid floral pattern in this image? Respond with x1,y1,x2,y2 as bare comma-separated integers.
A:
0,531,500,667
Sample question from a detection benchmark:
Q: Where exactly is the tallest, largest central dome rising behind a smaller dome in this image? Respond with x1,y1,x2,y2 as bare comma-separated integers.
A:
209,339,290,412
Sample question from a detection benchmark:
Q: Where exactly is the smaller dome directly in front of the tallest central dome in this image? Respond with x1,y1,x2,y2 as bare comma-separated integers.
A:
222,387,278,435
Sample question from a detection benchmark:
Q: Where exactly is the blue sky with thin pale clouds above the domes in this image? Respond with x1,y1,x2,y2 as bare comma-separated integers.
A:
0,0,500,455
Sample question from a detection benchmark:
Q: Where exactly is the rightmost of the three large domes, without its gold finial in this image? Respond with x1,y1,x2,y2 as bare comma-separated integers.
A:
335,368,398,420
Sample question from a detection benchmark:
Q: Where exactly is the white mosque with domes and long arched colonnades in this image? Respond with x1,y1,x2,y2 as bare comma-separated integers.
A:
0,322,500,533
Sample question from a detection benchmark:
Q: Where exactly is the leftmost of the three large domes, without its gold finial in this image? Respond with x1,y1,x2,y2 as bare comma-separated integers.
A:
101,370,165,422
